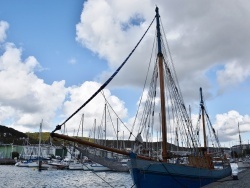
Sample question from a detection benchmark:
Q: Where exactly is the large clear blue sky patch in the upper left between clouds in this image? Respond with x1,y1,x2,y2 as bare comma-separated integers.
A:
1,0,107,86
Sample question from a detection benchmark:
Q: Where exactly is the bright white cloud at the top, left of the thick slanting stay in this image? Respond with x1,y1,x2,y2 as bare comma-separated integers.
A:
76,0,153,67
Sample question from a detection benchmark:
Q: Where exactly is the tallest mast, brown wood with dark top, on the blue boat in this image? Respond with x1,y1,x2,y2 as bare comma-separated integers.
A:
155,7,167,161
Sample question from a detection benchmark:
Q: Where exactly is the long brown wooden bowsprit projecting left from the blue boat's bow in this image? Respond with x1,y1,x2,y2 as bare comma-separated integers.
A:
51,133,153,160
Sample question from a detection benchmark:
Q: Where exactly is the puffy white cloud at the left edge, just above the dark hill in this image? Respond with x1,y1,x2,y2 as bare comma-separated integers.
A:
0,43,67,130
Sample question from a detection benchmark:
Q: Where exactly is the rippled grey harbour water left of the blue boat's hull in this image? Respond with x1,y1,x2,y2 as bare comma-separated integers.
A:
0,165,133,188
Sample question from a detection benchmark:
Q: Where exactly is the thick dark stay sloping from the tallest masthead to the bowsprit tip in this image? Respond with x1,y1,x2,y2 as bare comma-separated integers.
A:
52,17,155,134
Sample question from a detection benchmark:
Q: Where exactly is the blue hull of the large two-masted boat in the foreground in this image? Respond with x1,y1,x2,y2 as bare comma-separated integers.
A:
128,153,232,188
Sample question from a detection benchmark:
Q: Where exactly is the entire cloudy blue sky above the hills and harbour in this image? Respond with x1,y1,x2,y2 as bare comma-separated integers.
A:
0,0,250,146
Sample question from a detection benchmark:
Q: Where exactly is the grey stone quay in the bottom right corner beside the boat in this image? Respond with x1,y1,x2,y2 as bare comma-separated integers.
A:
202,169,250,188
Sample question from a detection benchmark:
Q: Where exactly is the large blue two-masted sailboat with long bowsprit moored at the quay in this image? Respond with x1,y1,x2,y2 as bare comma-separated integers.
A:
51,7,231,188
